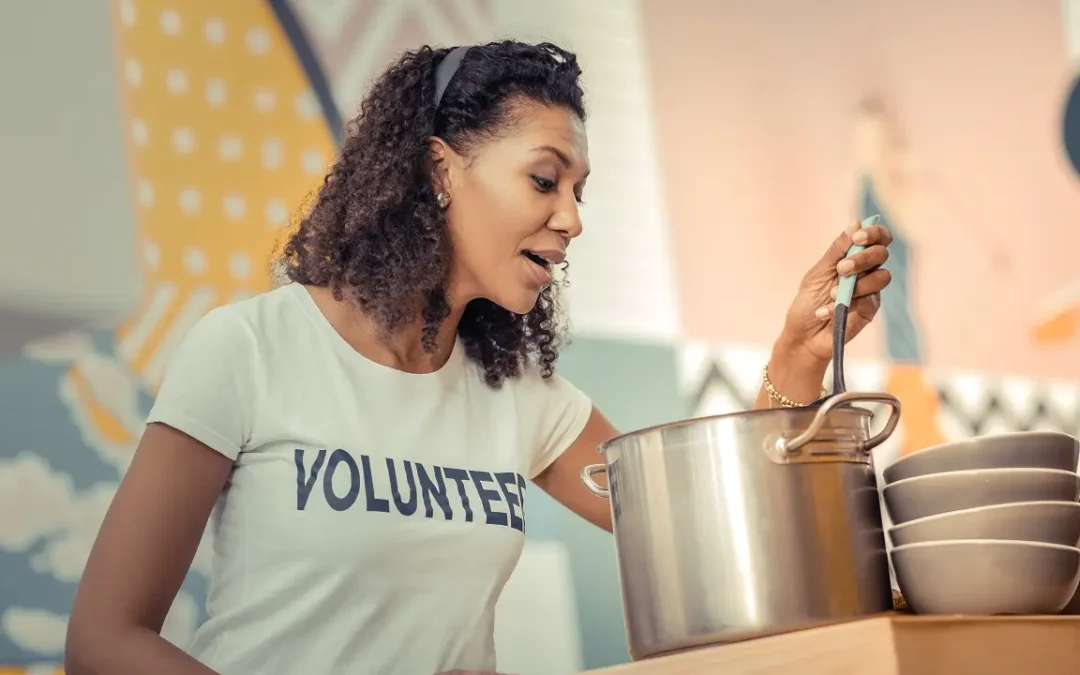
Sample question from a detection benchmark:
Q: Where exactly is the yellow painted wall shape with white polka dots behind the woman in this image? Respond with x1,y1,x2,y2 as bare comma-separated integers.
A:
113,0,334,374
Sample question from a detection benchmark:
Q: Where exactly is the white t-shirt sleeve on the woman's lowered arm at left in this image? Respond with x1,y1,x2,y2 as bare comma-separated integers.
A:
147,307,260,459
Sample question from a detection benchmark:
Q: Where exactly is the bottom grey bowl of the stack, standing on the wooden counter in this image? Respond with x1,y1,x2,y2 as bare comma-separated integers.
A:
889,539,1080,615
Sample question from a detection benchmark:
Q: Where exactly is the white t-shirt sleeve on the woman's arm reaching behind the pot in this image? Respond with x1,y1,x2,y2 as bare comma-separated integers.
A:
522,373,593,480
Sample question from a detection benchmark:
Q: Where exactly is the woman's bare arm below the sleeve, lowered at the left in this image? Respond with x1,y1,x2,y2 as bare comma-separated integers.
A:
64,424,232,675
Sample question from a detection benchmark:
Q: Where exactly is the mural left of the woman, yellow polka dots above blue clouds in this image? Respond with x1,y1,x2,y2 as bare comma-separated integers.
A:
0,0,336,663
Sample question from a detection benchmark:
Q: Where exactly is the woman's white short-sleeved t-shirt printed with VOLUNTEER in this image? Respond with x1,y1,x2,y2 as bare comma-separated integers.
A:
148,284,592,675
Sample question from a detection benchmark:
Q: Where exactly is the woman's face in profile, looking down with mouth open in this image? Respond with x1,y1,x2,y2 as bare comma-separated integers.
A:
435,102,589,314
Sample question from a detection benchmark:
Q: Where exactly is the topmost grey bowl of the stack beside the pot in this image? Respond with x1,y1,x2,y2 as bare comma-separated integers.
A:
881,431,1080,485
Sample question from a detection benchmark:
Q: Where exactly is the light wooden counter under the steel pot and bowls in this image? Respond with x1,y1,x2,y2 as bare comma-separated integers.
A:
589,613,1080,675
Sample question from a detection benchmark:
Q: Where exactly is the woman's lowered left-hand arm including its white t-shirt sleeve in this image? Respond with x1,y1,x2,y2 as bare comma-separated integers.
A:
65,308,257,675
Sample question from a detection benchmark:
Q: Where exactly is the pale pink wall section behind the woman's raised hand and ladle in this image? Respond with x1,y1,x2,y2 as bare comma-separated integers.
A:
643,0,1080,378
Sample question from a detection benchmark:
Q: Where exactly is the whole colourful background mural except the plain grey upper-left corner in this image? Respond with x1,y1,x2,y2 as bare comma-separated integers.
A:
6,0,1080,674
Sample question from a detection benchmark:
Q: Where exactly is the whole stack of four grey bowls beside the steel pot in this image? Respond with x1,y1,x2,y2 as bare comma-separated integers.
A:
882,432,1080,615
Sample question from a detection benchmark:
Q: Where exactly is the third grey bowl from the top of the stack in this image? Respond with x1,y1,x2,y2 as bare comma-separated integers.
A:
889,501,1080,546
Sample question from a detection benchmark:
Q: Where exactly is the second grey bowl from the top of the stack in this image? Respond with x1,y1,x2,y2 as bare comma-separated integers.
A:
881,469,1080,525
